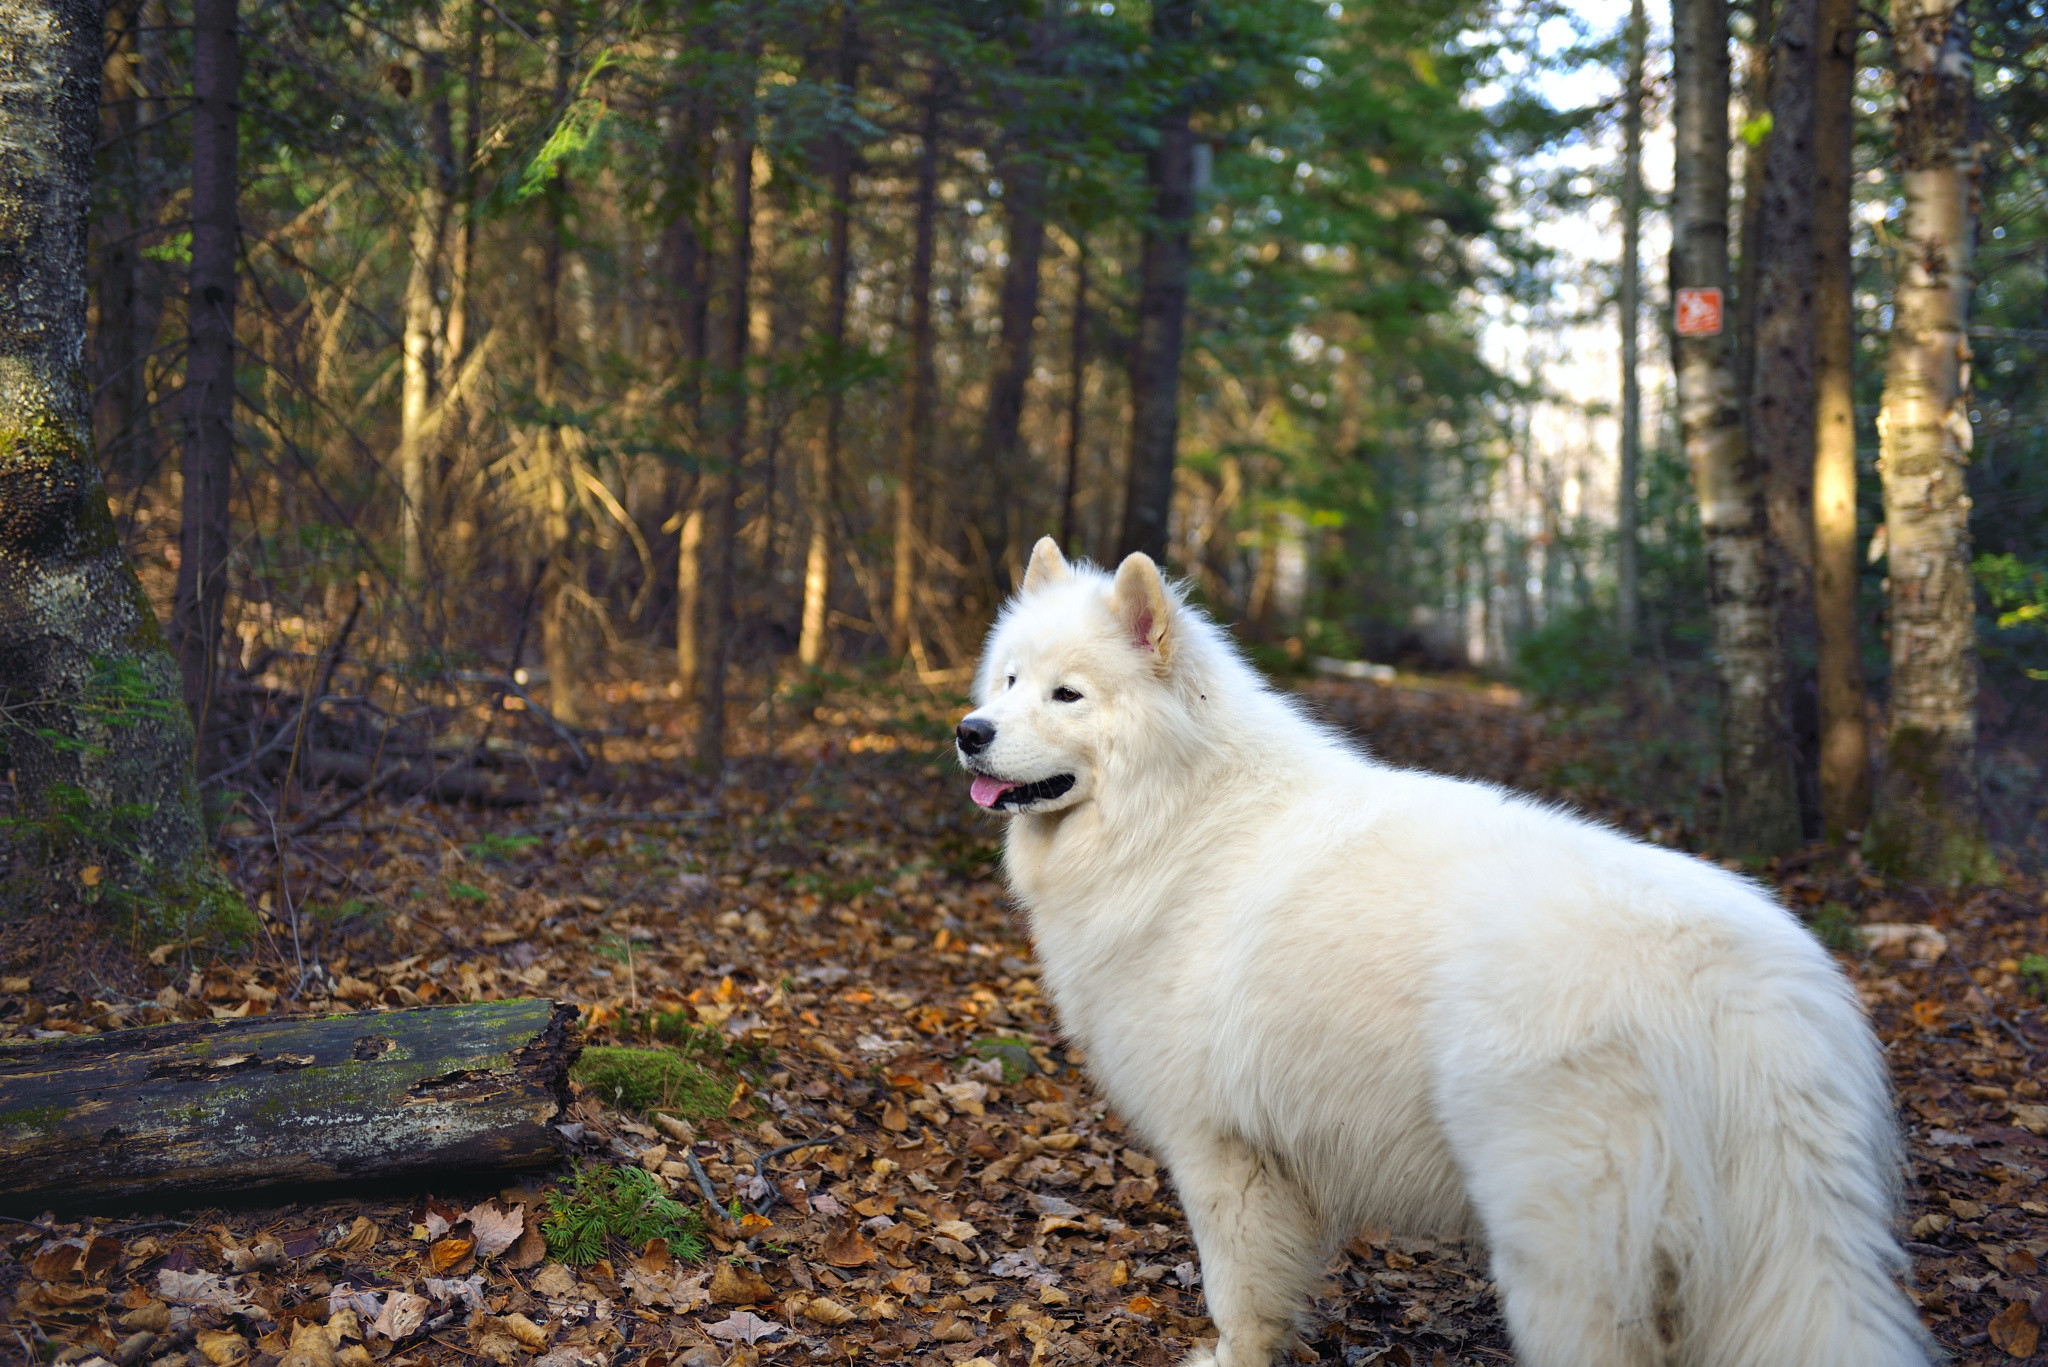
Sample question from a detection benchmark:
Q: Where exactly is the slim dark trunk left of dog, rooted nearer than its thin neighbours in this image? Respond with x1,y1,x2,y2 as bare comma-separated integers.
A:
696,98,754,777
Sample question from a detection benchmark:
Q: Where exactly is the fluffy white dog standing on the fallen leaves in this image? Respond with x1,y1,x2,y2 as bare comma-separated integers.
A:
956,539,1927,1367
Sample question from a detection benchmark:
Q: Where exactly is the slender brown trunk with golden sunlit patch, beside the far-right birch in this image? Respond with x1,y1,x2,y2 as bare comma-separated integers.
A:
1812,0,1870,840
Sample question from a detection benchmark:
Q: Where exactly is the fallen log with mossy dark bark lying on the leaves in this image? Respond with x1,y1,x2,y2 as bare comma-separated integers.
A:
0,1000,580,1213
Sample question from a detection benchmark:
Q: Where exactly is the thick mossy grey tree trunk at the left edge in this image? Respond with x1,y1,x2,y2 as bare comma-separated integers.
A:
0,0,246,922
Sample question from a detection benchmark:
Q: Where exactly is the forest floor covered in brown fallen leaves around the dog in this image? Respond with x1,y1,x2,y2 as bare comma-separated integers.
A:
0,678,2048,1367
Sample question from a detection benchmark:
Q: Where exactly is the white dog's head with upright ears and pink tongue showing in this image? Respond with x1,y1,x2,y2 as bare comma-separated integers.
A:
954,537,1188,814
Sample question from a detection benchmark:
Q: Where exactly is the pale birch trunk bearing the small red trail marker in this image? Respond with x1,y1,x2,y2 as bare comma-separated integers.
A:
1671,0,1798,855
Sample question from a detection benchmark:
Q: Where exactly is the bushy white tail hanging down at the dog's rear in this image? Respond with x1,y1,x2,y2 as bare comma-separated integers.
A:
1671,945,1929,1367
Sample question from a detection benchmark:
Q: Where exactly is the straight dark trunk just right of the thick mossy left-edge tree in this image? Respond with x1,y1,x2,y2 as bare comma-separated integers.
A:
170,0,242,754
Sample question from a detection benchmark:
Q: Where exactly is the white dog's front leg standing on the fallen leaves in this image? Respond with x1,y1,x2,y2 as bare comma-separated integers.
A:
1171,1140,1321,1367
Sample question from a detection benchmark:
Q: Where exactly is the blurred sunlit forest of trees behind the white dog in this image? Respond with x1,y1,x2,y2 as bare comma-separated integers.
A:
12,0,2048,909
